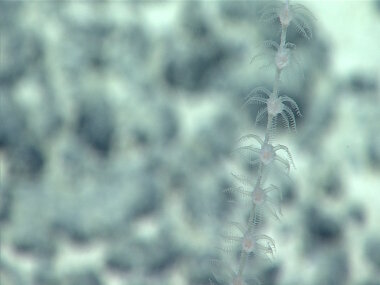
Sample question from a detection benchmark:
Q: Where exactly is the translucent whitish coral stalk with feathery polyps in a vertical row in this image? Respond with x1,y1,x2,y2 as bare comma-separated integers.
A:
210,0,314,285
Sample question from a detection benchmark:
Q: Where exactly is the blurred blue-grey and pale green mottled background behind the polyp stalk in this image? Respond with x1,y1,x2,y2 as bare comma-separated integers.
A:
0,0,380,285
